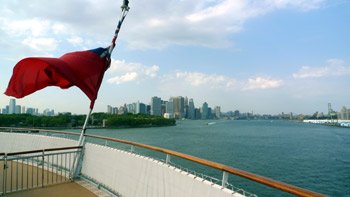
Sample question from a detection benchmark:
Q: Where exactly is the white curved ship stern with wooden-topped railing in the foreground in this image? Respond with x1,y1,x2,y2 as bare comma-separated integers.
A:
0,127,322,197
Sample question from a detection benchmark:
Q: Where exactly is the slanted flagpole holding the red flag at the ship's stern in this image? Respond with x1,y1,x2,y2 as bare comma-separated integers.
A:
69,0,130,180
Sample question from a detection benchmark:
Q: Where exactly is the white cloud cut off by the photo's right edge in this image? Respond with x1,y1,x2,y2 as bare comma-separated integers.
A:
293,59,350,78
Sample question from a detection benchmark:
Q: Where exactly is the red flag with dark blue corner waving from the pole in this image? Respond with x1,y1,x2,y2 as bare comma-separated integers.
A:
5,48,110,109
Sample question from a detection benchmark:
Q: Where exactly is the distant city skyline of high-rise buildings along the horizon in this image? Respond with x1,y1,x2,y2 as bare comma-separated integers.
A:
0,96,350,120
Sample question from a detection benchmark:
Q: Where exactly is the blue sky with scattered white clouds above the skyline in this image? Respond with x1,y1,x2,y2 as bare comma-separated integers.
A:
0,0,350,114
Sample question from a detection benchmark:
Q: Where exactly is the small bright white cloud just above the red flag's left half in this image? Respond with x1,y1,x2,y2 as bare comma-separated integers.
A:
22,37,58,51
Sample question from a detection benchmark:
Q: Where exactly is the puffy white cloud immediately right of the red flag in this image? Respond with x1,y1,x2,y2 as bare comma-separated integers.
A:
107,60,159,84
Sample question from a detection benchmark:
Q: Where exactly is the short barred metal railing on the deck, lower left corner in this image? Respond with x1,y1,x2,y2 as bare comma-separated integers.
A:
0,146,83,196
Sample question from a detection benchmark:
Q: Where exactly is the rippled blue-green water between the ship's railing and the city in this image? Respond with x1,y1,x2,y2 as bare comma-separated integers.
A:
78,120,350,196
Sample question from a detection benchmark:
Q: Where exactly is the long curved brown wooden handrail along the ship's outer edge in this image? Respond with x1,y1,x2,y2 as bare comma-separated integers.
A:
0,127,324,197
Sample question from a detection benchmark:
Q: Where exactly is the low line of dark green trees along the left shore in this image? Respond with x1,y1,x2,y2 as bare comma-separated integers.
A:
0,113,176,128
